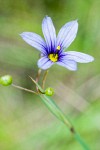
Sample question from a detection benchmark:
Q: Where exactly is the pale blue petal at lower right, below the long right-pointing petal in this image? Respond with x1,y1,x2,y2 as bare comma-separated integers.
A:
57,59,77,71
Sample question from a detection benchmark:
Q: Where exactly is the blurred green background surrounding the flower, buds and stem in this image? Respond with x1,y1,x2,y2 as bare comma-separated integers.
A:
0,0,100,150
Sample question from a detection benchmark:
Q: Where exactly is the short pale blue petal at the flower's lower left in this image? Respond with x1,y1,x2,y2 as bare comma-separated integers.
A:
38,57,54,70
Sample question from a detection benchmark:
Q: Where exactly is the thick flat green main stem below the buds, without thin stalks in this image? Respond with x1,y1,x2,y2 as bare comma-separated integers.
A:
39,95,90,150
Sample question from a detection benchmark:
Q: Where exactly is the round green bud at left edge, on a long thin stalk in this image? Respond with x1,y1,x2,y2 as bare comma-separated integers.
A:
0,75,12,86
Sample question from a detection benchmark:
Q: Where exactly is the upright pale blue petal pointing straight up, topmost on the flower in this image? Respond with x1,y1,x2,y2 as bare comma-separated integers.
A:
42,16,56,51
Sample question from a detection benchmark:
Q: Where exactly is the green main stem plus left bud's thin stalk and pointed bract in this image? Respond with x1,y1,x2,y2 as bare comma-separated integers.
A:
12,77,90,150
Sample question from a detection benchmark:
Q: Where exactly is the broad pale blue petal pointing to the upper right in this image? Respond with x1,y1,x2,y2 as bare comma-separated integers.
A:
57,20,78,49
